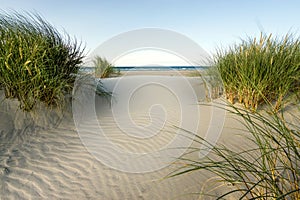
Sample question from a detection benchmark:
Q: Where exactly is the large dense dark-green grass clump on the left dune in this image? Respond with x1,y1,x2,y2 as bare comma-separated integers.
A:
0,12,83,110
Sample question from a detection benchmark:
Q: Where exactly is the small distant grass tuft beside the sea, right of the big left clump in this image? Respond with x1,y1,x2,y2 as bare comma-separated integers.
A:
93,56,120,78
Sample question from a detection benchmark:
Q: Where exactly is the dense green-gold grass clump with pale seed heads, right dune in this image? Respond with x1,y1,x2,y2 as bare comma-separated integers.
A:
214,34,300,110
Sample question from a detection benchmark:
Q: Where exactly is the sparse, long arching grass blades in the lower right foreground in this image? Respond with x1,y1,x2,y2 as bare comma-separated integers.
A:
170,106,300,200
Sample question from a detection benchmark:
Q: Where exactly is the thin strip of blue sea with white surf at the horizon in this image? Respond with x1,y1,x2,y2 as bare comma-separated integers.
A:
80,66,209,72
